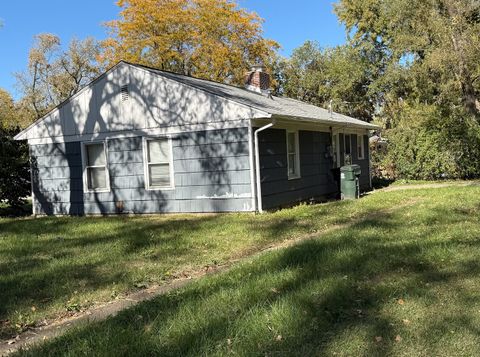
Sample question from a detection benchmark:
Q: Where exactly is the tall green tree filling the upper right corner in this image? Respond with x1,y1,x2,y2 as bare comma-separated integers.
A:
336,0,480,119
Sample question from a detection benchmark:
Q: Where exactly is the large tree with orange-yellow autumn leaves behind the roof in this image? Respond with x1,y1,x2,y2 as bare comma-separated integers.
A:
103,0,278,84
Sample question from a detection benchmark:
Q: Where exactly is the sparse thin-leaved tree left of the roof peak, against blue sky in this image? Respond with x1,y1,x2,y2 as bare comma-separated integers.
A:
16,33,102,119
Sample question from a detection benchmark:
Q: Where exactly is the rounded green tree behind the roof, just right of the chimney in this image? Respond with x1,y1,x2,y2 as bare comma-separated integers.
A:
282,41,376,121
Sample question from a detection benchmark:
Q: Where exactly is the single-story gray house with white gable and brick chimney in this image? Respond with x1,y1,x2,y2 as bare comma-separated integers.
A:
15,61,376,215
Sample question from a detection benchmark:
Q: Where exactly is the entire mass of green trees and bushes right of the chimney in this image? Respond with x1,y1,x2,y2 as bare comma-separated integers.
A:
283,0,480,179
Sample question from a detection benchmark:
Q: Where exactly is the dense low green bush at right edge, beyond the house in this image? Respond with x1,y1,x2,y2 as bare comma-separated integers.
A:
374,106,480,180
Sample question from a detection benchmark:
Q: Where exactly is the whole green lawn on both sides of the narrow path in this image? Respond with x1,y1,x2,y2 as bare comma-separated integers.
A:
0,182,480,356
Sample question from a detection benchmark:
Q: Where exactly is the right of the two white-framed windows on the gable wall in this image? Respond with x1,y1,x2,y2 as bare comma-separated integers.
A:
145,138,173,189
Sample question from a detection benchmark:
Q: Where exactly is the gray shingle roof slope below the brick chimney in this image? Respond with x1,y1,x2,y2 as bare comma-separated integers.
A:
129,63,378,129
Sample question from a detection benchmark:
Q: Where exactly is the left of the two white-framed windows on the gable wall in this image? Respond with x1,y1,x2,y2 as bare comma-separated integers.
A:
85,143,108,191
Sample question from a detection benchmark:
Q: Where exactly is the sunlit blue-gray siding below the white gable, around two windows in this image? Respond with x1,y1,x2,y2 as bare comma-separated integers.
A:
31,128,252,215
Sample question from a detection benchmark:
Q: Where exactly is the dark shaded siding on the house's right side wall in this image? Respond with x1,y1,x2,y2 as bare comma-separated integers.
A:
259,129,337,208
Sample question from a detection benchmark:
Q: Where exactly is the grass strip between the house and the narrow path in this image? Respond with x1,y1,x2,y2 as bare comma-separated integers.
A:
0,192,400,338
